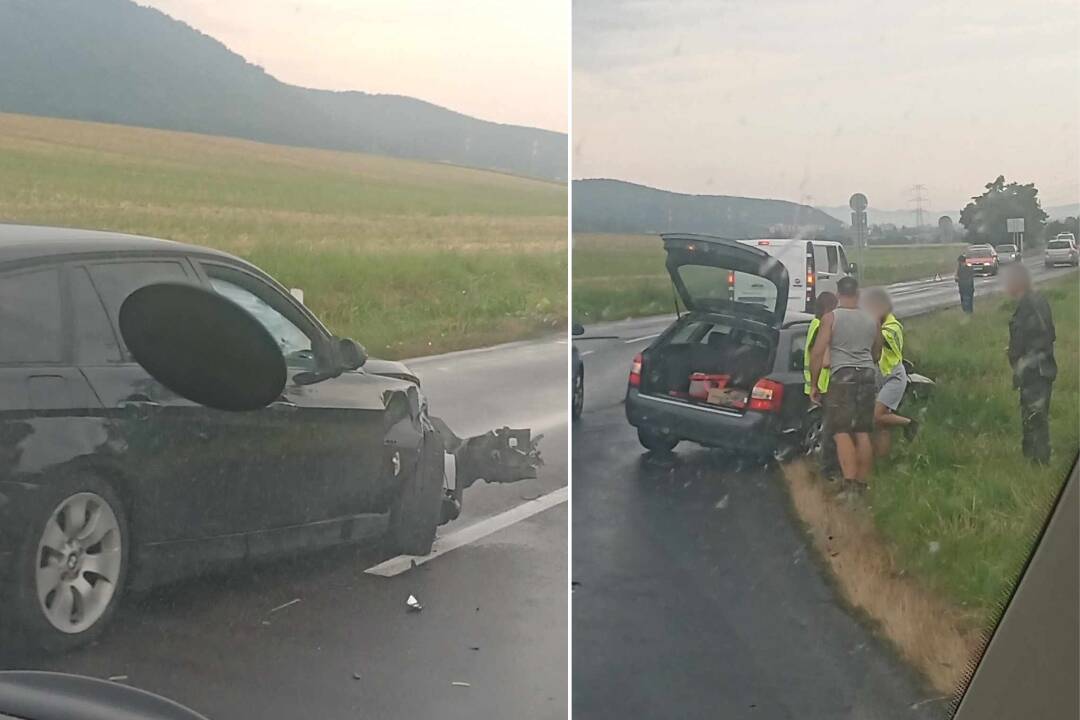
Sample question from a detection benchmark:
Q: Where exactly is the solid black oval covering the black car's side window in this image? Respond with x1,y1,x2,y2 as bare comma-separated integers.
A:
120,283,286,410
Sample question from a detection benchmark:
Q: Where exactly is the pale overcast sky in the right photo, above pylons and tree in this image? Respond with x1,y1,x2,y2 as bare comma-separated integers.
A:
572,0,1080,210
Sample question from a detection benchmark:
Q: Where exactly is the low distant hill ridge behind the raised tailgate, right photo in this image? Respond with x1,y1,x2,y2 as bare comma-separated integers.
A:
572,179,843,239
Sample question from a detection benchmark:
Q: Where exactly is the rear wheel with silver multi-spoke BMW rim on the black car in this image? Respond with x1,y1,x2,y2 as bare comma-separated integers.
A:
12,475,132,653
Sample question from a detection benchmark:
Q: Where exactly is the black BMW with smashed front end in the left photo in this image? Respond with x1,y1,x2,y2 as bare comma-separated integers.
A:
0,225,531,650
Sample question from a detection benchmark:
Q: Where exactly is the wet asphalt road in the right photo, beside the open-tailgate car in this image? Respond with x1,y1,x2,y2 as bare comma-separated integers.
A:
571,264,1068,720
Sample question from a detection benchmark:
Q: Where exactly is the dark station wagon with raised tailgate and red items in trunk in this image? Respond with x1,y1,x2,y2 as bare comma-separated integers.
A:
626,234,821,457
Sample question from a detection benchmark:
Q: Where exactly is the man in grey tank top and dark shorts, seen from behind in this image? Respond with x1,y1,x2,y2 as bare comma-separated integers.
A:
810,277,881,490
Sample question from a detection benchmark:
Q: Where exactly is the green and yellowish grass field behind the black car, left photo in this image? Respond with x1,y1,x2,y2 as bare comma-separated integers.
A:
0,113,566,357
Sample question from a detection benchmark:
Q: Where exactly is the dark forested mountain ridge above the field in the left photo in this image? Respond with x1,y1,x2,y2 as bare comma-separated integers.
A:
0,0,567,180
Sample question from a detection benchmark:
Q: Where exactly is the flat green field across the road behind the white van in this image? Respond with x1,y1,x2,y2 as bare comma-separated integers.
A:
573,234,961,322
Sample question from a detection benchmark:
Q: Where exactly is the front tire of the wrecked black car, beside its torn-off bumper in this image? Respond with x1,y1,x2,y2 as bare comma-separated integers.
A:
389,433,444,555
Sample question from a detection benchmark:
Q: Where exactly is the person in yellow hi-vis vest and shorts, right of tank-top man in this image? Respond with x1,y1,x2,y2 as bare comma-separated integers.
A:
864,287,919,458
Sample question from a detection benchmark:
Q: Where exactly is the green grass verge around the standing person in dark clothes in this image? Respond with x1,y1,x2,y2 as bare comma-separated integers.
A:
870,274,1080,622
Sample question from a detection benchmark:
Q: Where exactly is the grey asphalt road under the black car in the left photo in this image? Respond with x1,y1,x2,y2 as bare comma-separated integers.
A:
0,338,568,720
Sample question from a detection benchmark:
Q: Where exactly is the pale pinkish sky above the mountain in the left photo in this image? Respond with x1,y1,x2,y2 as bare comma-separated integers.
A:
137,0,570,132
